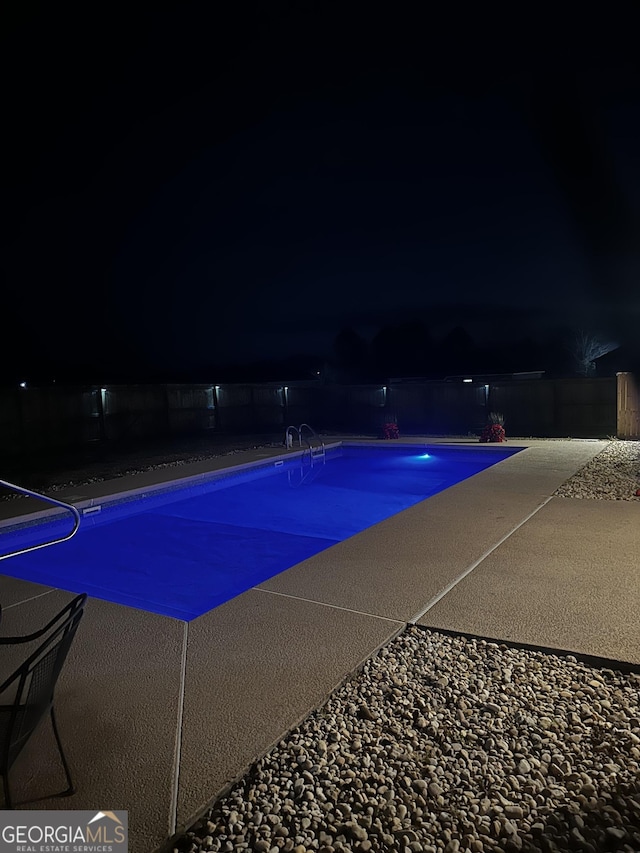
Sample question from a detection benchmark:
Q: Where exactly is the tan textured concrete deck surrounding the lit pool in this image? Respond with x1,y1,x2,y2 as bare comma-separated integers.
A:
0,438,640,853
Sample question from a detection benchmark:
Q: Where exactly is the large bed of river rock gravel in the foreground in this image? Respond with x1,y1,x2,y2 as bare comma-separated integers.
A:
175,626,640,853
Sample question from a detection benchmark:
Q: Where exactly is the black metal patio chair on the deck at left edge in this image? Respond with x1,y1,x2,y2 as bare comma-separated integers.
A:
0,593,87,809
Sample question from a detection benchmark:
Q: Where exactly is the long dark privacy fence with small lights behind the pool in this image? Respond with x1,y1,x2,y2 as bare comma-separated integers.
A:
0,373,640,458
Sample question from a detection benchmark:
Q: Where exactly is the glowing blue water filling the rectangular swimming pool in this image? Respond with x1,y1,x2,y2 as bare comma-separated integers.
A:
0,446,521,621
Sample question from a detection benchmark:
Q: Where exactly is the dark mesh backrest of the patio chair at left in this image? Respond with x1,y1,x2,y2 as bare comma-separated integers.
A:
0,595,86,769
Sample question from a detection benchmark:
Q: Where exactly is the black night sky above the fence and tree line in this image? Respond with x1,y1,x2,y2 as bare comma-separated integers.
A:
0,0,640,382
